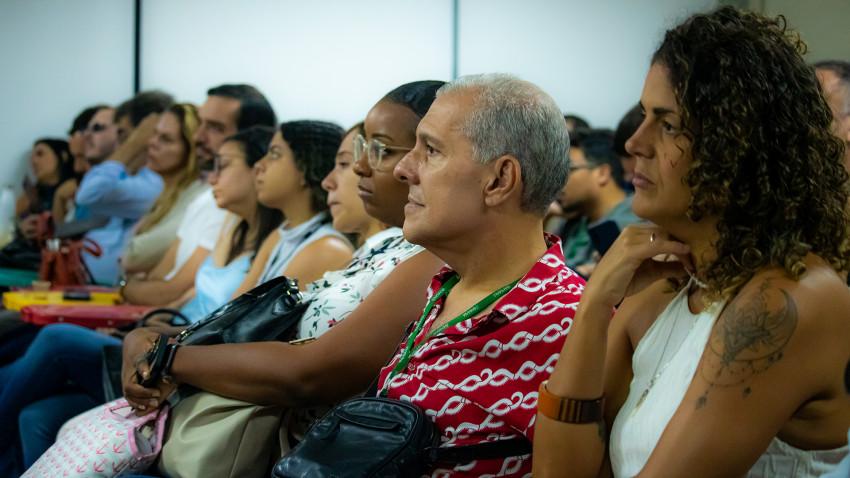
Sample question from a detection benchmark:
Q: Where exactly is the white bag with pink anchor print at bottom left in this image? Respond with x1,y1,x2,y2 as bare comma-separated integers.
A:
22,398,168,478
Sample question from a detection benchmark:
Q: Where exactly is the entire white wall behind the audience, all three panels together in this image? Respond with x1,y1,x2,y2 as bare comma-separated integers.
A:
0,0,748,190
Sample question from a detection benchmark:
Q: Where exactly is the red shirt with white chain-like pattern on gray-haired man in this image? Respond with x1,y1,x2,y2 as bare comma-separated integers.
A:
378,236,584,477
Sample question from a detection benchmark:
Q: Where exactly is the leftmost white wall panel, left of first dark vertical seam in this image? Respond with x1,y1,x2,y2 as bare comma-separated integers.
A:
0,0,133,187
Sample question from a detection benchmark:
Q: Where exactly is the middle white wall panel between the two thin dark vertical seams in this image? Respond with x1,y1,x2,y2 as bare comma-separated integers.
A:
142,0,452,127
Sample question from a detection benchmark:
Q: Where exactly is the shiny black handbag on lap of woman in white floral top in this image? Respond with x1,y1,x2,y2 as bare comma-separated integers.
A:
177,277,307,345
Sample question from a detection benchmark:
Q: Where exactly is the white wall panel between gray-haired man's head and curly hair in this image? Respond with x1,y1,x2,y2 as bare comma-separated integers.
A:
459,0,717,128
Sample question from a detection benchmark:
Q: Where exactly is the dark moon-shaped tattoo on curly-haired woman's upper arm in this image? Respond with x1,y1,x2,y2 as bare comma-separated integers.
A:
696,280,798,408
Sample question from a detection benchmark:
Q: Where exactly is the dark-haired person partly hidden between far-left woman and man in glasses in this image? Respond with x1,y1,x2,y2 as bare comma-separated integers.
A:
53,106,103,224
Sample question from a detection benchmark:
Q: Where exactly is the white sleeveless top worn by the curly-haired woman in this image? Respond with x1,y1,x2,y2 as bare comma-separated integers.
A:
609,284,847,478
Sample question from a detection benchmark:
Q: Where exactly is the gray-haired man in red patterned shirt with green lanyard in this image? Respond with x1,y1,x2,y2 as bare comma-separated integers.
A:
378,74,584,476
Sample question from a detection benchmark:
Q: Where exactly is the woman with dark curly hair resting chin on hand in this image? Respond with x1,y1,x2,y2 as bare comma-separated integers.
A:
534,7,850,477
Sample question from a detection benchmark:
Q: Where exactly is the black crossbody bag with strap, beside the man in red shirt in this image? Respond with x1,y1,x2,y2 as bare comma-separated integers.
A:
272,397,531,478
